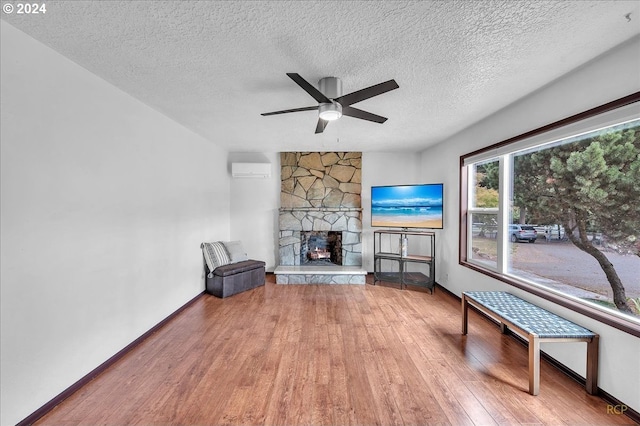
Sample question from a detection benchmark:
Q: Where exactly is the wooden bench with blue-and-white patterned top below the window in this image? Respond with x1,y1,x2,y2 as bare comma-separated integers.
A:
462,291,599,395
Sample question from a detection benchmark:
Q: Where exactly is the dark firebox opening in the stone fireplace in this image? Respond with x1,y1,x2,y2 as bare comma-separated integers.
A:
300,231,342,266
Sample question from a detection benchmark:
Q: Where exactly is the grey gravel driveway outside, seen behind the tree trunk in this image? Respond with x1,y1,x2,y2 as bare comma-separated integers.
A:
513,240,640,300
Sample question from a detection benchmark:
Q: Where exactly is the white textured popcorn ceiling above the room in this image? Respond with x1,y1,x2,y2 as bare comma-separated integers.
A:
2,0,640,152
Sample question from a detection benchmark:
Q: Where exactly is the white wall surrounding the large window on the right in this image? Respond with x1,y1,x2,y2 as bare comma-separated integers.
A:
422,37,640,411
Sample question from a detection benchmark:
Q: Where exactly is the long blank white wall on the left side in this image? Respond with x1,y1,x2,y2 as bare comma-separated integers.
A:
0,21,230,425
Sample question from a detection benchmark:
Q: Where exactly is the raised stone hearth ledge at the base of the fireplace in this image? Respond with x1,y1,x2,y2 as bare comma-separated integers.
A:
273,265,367,284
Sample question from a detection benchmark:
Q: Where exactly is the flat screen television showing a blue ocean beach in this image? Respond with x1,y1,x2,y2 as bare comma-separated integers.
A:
371,183,443,229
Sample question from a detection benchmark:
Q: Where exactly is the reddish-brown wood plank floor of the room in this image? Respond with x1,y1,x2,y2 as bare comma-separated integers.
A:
37,275,634,425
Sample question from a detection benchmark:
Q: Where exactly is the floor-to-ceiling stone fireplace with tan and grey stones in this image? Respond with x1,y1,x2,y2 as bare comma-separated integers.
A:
275,152,366,284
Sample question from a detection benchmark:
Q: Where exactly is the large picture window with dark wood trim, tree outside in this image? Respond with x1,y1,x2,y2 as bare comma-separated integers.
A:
460,93,640,336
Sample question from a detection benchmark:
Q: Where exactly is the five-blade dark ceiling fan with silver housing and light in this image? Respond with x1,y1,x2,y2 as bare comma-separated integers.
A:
260,73,400,133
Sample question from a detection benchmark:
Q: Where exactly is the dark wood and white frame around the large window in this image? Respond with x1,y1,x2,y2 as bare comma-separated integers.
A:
458,92,640,337
